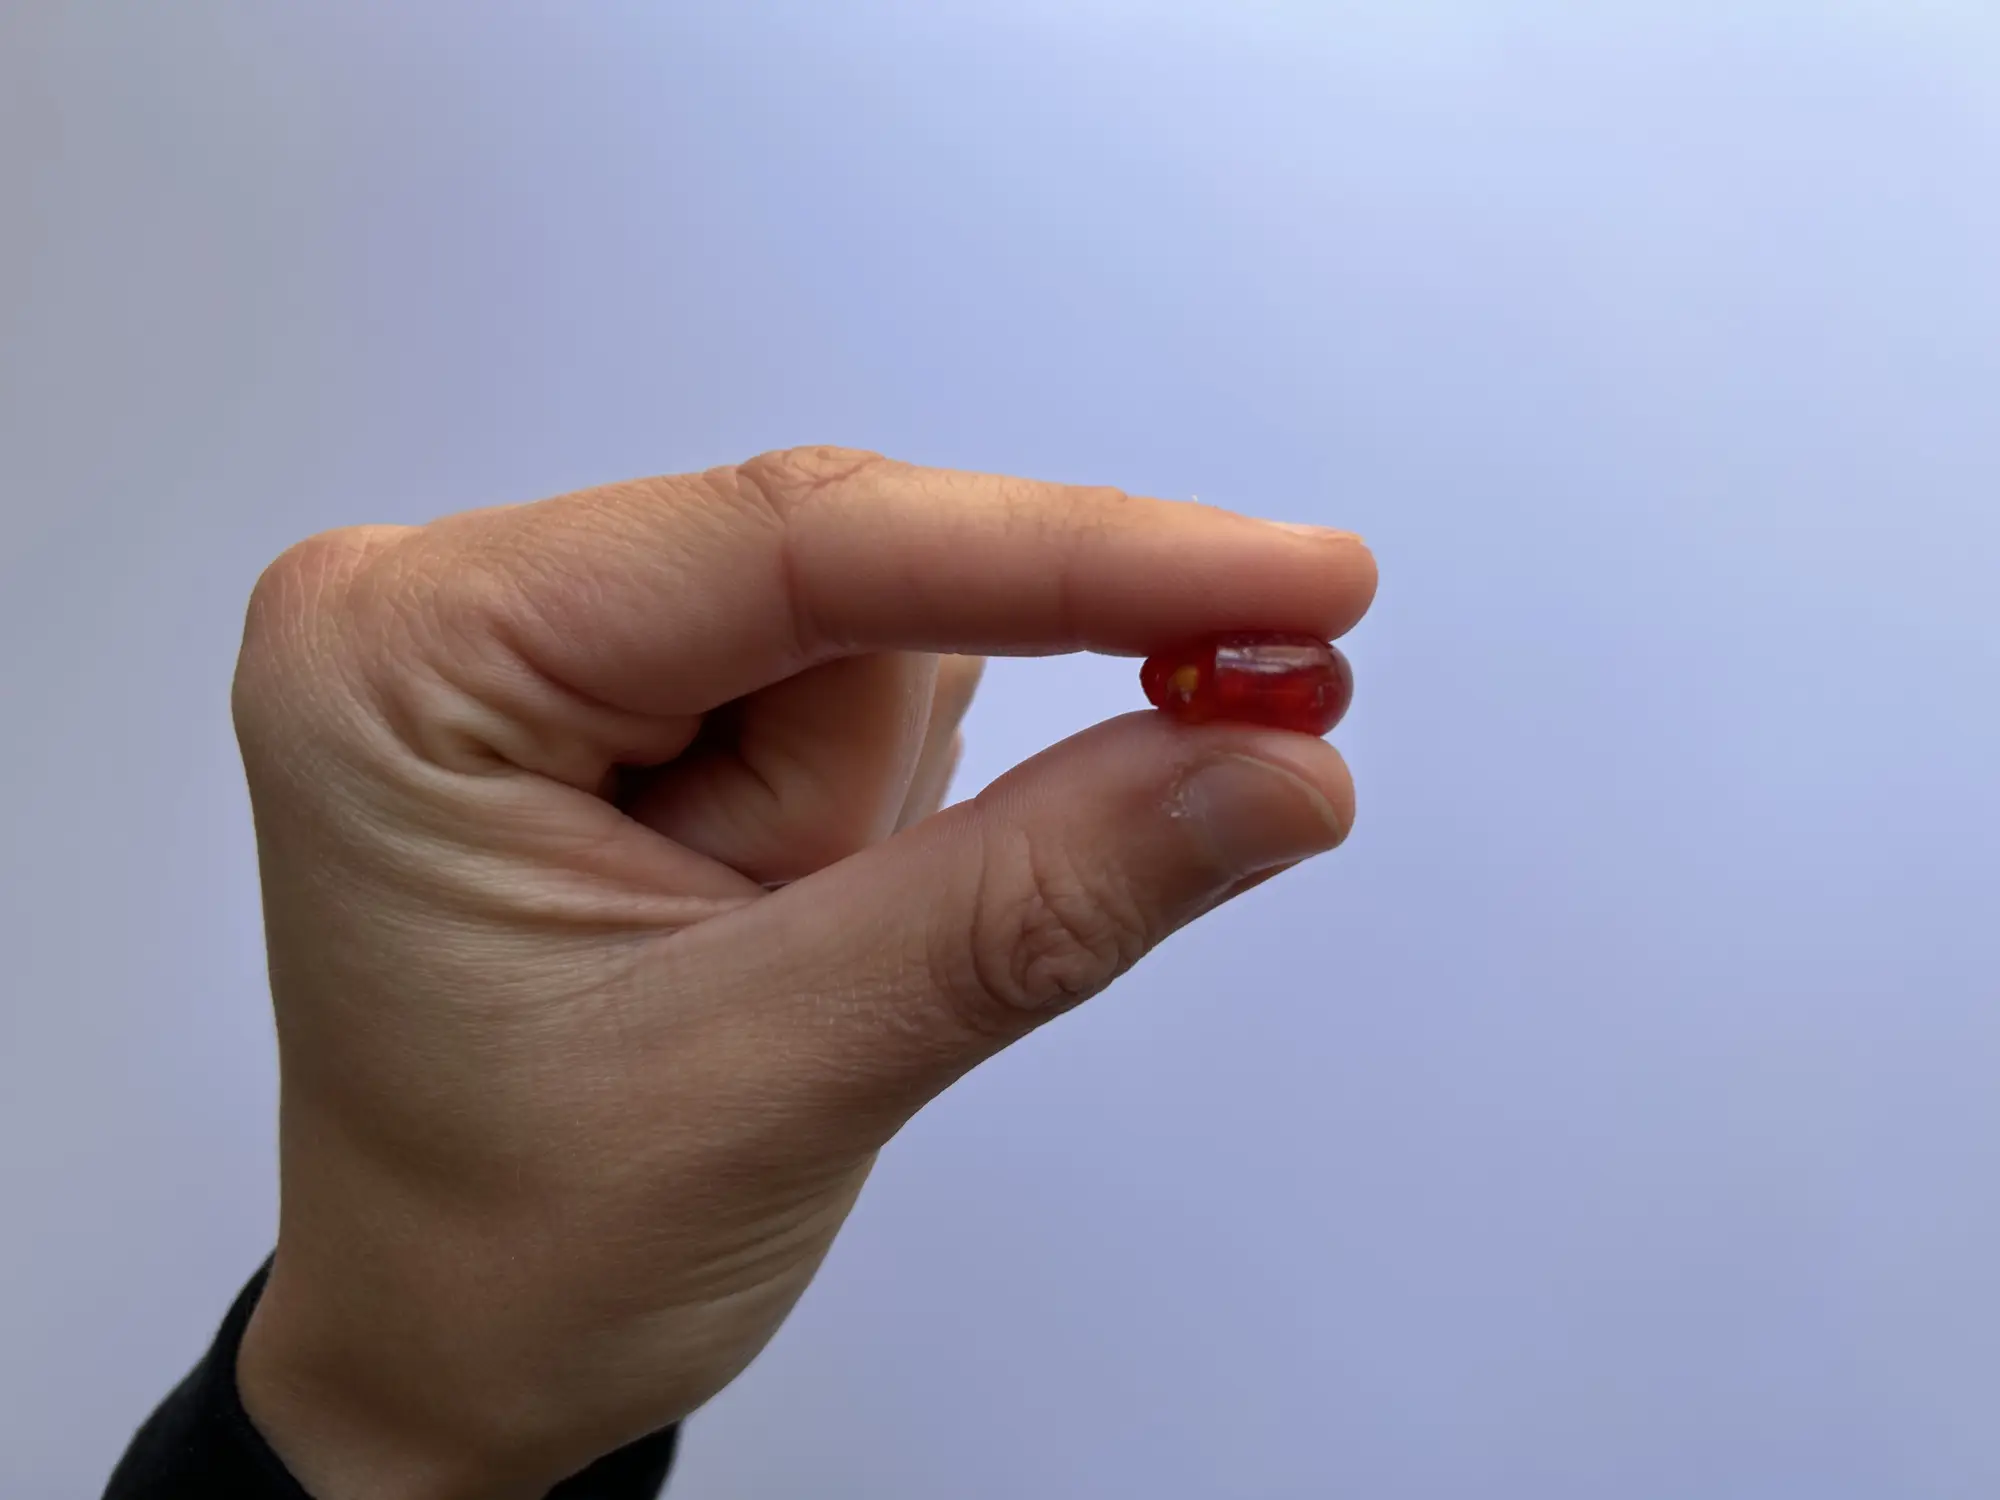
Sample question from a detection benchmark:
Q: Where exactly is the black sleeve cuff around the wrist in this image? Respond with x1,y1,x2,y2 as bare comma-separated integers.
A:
104,1260,678,1500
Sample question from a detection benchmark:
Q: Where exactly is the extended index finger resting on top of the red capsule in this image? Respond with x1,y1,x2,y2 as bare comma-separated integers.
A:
406,448,1376,714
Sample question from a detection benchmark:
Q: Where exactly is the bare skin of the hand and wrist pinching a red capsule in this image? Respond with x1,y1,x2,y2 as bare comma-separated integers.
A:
234,448,1376,1500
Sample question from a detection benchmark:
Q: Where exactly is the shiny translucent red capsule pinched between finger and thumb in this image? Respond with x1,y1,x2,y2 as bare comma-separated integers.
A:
1138,630,1354,734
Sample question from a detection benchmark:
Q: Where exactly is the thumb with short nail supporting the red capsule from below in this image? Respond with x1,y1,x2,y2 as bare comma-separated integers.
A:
682,712,1354,1146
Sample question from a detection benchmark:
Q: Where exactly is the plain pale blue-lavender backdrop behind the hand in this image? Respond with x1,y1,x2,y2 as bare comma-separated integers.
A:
0,0,2000,1500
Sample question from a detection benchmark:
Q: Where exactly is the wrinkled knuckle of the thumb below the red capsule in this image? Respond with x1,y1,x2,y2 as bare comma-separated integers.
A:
946,830,1152,1036
